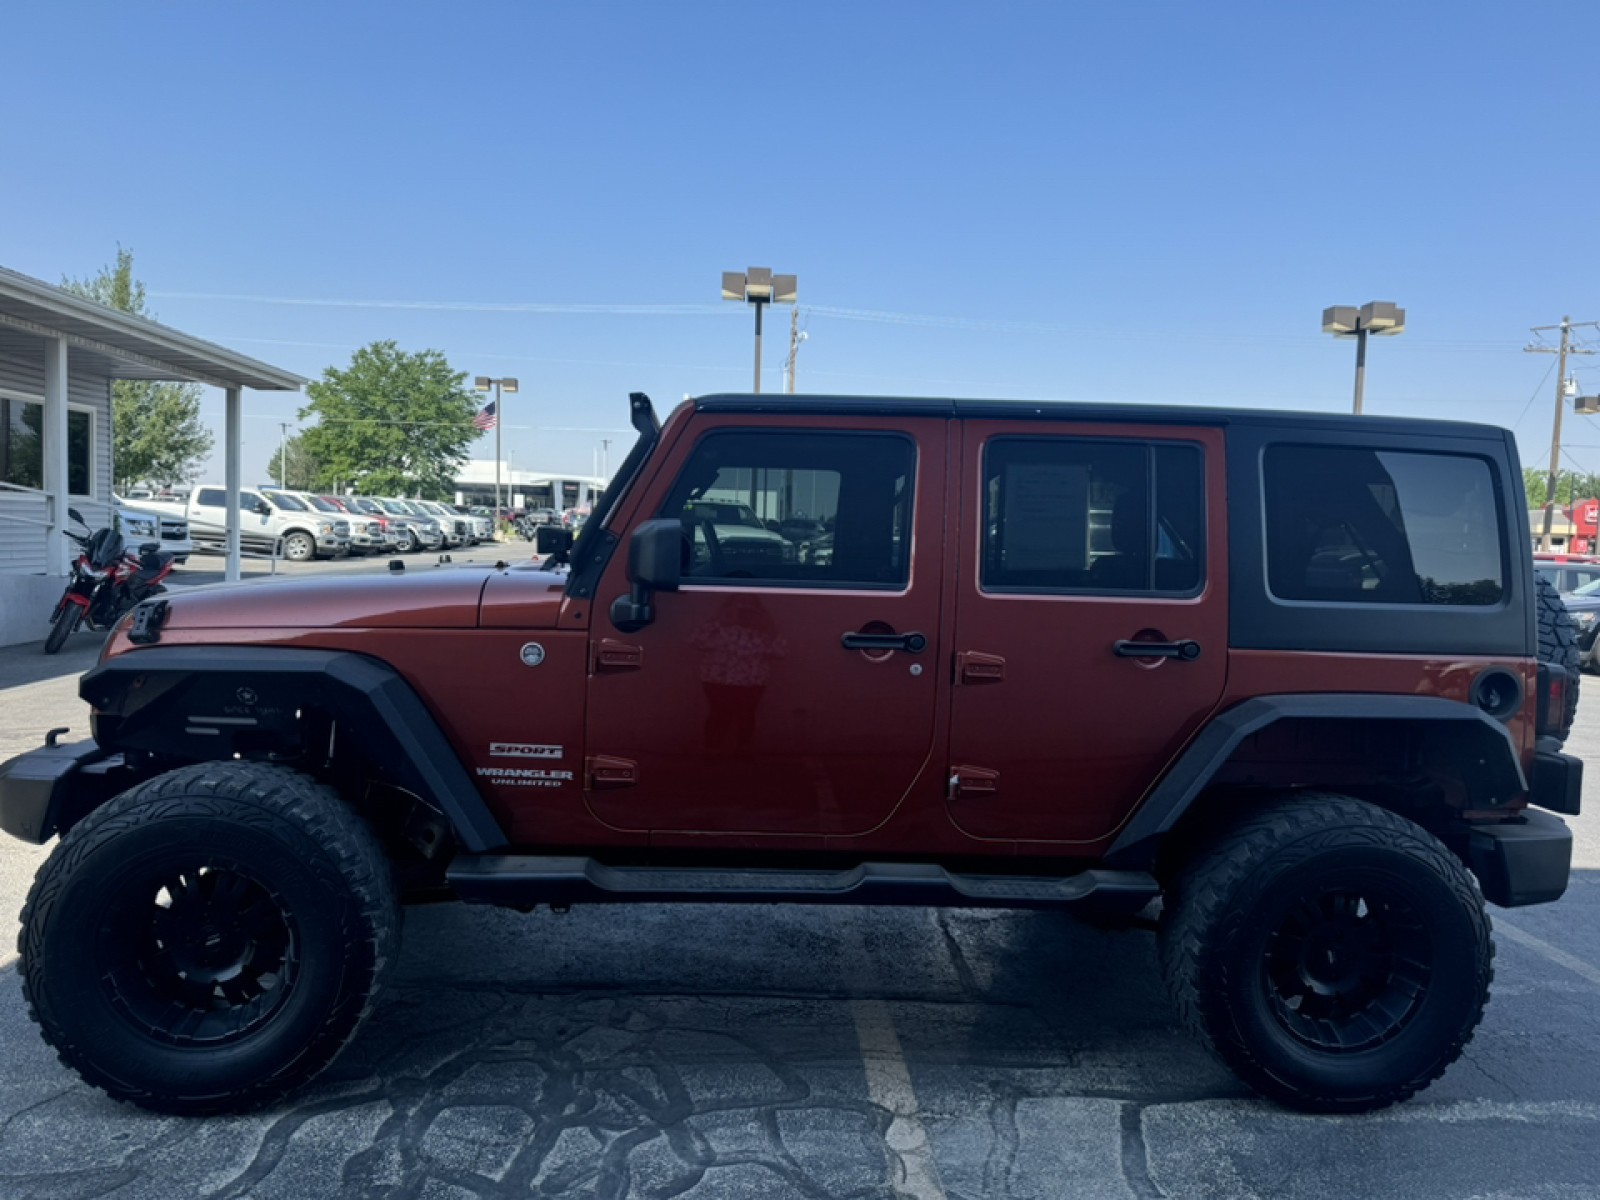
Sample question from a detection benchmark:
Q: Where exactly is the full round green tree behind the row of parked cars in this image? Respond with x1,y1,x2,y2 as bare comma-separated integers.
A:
299,341,478,499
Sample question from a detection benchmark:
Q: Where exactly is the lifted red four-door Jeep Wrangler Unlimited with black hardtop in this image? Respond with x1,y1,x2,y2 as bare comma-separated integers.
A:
0,395,1582,1112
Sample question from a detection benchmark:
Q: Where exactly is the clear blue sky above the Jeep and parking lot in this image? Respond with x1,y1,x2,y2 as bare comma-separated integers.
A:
0,0,1600,478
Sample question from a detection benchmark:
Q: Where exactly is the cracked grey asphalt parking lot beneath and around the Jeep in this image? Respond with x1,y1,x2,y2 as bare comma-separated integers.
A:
0,566,1600,1200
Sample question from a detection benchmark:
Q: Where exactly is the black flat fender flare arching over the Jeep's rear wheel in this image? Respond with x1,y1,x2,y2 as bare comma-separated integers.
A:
1106,693,1528,870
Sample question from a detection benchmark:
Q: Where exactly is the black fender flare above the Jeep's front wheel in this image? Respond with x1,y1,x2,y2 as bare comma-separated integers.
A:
78,645,507,854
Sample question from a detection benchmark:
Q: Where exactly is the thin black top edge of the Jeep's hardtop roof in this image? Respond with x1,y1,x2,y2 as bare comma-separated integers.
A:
693,394,1507,442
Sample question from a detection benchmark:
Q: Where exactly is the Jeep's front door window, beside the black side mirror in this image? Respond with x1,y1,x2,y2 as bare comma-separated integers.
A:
661,430,915,587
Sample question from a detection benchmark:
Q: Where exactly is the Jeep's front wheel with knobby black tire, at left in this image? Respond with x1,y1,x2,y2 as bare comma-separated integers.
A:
18,762,400,1114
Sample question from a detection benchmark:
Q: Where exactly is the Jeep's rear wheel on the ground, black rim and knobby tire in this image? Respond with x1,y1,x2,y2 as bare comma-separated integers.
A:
1160,795,1494,1112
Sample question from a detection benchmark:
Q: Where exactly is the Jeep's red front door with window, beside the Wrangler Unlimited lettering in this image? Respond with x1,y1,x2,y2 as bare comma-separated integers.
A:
586,413,949,846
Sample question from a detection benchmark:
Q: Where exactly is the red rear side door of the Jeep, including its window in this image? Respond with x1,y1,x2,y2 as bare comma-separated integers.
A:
947,419,1227,853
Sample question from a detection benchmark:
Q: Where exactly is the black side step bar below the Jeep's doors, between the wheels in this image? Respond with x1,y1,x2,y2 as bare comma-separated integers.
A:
446,854,1162,915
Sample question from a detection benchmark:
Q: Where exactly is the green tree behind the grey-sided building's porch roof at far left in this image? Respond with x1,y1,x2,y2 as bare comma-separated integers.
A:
61,246,213,486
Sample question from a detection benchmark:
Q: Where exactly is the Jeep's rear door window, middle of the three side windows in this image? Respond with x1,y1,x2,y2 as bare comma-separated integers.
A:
979,437,1205,595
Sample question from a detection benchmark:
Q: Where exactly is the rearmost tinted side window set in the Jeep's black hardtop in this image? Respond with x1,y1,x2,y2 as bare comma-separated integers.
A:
1262,446,1506,605
